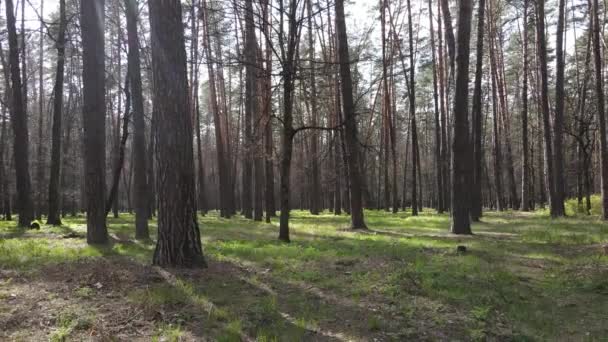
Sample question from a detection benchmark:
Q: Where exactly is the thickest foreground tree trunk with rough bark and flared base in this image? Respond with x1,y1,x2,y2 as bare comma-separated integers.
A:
148,0,206,267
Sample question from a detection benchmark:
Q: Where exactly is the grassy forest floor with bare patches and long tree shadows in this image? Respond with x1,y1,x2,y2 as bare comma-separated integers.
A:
0,204,608,341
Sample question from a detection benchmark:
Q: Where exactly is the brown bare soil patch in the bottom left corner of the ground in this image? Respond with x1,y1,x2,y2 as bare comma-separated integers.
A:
0,258,170,341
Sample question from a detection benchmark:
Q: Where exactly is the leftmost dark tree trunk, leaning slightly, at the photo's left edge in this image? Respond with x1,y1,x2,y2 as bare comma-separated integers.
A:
6,0,34,227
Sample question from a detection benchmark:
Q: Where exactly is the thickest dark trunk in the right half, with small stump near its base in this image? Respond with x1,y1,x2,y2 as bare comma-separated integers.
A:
452,0,473,234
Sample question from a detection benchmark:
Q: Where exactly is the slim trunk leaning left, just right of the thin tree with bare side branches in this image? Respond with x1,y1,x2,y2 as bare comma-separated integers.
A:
335,0,367,229
